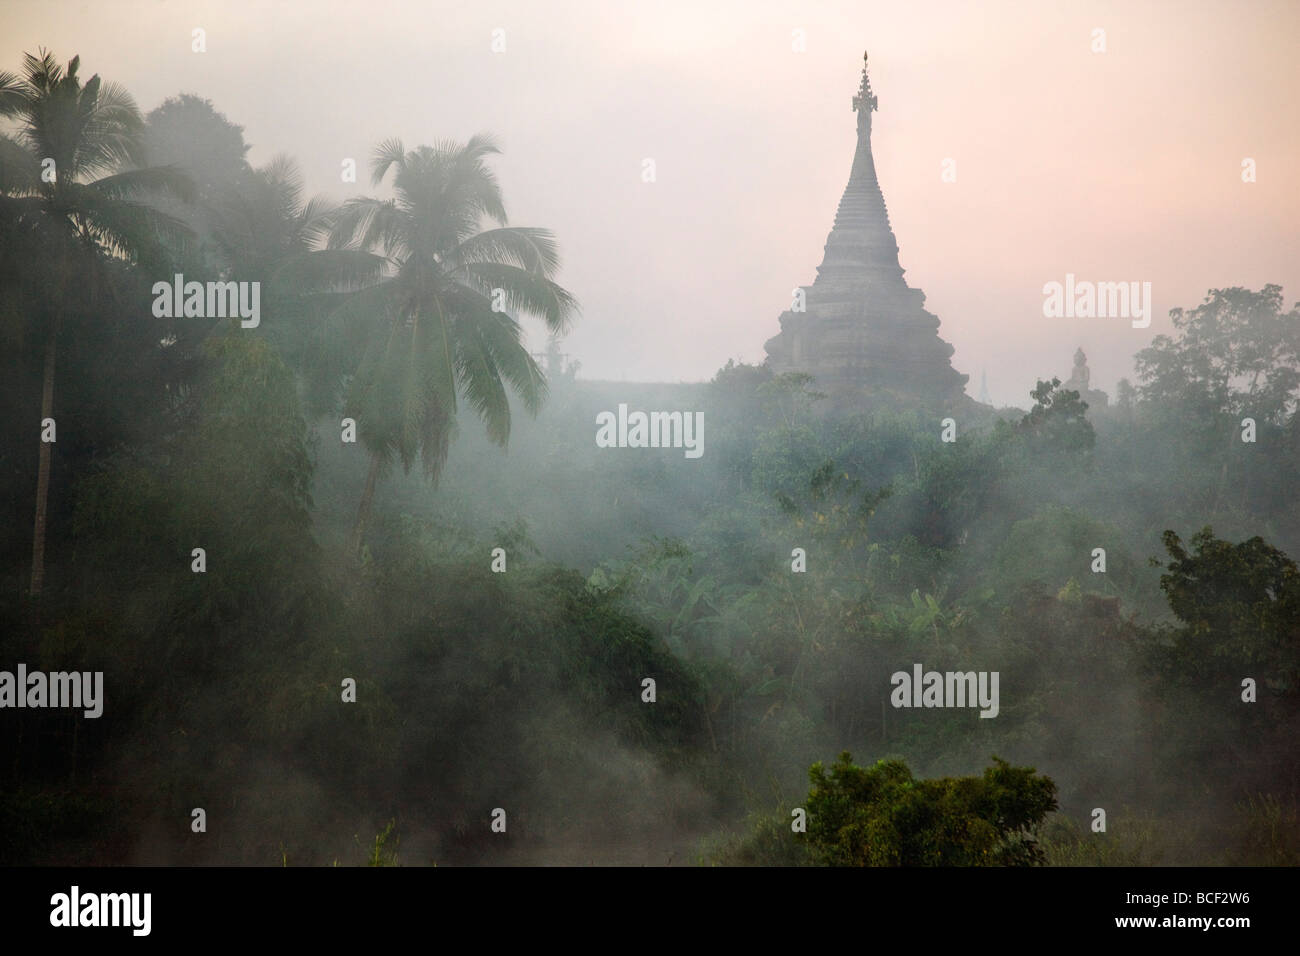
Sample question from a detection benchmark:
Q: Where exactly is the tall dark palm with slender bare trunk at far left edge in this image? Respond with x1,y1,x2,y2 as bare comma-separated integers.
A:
0,51,194,597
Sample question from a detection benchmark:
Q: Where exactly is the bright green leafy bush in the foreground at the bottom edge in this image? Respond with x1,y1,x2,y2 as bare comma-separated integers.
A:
807,752,1057,866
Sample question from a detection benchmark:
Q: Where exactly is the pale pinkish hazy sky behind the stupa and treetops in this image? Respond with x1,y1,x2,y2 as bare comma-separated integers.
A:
0,0,1300,406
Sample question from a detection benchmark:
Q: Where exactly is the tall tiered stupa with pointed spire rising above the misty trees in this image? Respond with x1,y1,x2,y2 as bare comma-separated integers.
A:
766,55,967,406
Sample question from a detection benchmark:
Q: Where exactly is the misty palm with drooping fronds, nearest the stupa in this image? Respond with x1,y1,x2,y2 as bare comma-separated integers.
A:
319,135,577,553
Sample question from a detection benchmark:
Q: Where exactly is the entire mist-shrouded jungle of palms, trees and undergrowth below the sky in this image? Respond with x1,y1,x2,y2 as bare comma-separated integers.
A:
0,48,1300,865
